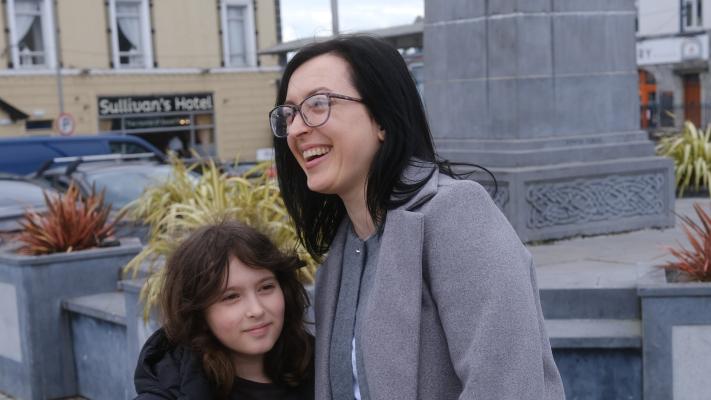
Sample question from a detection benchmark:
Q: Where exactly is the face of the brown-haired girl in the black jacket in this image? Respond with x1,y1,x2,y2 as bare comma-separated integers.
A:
205,257,284,359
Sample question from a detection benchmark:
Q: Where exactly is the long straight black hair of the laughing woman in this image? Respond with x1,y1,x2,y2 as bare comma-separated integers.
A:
274,35,444,259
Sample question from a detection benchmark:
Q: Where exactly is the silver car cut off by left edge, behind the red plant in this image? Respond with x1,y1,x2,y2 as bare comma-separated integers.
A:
0,173,56,232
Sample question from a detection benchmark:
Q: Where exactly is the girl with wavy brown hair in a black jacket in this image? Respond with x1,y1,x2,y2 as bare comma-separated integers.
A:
135,222,314,400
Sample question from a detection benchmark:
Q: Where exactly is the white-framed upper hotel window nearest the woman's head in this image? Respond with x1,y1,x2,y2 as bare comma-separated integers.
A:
221,0,257,67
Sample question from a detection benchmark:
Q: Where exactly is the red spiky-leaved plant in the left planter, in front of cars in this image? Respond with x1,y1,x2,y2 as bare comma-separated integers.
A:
18,183,123,255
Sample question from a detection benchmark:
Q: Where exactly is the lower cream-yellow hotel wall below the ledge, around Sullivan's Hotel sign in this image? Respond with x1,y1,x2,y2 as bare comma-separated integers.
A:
0,72,279,161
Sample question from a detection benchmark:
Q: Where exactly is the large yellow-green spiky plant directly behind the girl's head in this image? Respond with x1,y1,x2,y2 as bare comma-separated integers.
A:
124,157,317,318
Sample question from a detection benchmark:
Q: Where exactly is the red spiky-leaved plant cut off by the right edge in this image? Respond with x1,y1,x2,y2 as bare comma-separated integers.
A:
664,203,711,282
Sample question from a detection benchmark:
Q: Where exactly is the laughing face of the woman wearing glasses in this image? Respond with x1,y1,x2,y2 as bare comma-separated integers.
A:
286,54,384,200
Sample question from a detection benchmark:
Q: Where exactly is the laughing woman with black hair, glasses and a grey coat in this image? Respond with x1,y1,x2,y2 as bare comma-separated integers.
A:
270,36,564,400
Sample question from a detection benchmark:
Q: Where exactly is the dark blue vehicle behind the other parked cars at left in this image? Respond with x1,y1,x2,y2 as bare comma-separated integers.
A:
0,135,165,175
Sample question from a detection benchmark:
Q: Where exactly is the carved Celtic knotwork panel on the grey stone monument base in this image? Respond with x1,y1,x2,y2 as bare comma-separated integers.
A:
526,174,664,229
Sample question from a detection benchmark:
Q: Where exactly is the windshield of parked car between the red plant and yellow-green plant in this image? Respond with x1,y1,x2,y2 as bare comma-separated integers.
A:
86,165,181,210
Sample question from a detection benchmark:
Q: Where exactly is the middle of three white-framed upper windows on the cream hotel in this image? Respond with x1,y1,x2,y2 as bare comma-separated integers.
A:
109,0,153,68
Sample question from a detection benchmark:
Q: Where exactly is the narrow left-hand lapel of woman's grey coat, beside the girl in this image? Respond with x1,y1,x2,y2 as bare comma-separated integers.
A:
314,218,349,400
